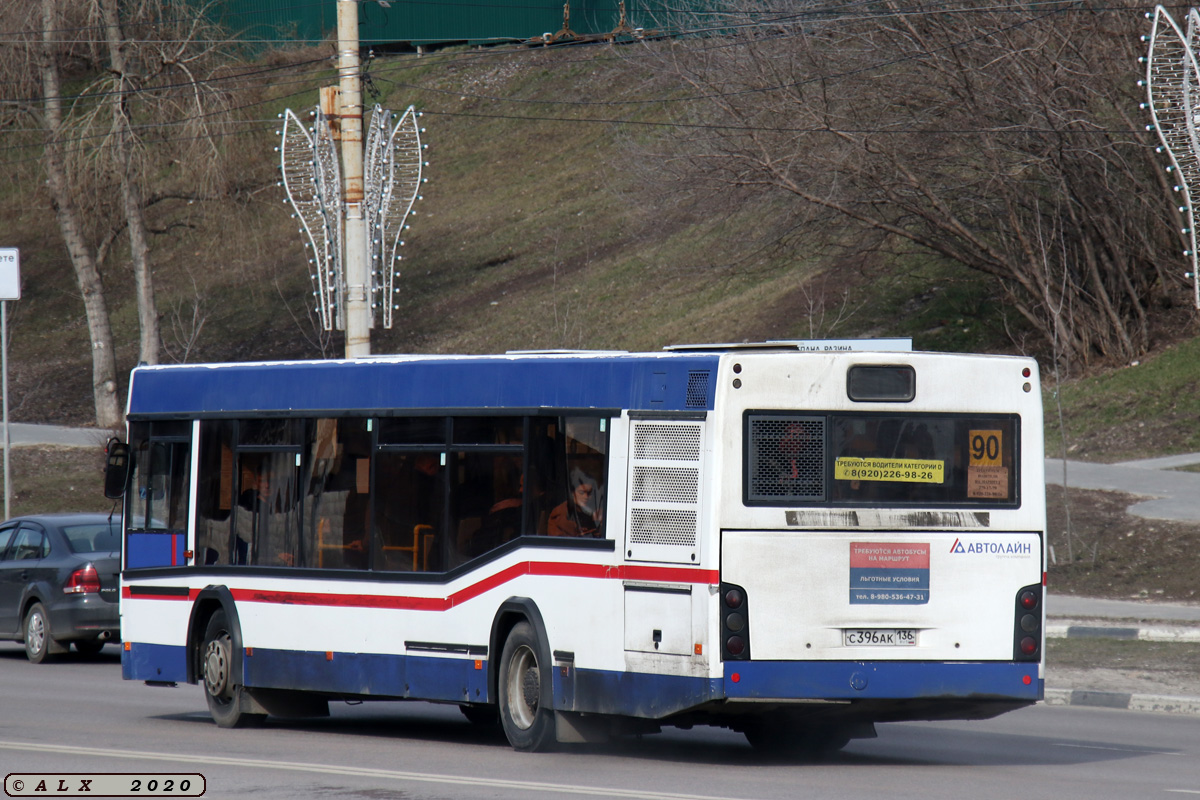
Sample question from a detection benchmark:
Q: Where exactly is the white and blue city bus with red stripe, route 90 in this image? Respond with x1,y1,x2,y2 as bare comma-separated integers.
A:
114,342,1045,752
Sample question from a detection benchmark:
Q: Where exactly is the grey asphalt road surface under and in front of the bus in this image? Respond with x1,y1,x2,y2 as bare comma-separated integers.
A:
0,643,1200,800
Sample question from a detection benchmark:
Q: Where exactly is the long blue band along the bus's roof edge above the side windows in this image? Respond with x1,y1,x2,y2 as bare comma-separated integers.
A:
130,354,718,416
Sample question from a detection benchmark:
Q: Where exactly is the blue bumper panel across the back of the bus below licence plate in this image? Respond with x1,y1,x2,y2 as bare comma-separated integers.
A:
725,661,1043,700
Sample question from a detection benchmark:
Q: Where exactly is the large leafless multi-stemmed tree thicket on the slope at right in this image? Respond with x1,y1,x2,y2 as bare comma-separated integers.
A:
643,0,1186,363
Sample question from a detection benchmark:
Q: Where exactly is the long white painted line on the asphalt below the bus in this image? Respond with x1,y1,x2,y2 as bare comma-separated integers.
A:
0,741,746,800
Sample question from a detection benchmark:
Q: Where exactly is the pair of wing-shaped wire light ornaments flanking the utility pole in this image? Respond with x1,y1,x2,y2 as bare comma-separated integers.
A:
280,106,424,331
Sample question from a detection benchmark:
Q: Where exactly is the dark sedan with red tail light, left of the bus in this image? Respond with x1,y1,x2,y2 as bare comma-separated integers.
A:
0,513,121,663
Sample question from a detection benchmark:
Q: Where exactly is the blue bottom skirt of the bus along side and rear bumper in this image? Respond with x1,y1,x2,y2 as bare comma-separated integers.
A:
121,642,1044,718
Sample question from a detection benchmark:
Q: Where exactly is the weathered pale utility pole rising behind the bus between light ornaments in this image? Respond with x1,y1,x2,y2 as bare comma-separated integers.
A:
337,0,371,359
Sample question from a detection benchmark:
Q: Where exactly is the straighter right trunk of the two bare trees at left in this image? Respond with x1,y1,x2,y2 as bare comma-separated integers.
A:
98,0,161,363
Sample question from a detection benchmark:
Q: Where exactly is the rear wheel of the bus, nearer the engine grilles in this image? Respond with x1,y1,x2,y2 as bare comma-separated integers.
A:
499,621,557,753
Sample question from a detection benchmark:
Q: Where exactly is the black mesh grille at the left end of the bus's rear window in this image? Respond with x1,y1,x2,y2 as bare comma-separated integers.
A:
746,414,826,504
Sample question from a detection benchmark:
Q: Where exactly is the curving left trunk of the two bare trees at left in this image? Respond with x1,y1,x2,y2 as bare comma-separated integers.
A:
38,0,121,428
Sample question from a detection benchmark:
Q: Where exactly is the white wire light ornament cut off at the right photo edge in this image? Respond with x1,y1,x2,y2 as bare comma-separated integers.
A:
1146,6,1200,308
